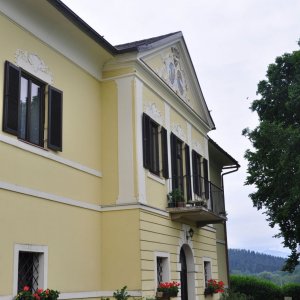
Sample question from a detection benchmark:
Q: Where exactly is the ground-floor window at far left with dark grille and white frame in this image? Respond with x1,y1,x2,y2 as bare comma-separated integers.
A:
14,244,48,295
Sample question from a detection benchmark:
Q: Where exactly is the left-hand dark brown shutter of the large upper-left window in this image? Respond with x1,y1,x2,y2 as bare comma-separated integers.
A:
3,61,21,135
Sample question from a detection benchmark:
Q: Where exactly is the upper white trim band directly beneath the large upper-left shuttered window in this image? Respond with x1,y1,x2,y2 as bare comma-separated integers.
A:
0,135,102,177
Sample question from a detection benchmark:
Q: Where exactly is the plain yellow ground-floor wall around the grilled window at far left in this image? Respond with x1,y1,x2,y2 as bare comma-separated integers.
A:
0,190,101,295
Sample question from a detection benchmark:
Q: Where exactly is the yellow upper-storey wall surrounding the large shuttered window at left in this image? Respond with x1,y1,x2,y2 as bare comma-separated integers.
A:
0,15,102,204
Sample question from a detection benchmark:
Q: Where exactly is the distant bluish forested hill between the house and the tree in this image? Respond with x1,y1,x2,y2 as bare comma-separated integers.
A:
229,249,285,274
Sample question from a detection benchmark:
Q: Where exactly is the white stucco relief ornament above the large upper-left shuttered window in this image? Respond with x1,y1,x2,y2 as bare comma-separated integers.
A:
15,49,53,84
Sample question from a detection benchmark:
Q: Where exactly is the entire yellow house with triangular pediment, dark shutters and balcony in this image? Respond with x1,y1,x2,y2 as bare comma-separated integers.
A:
0,0,239,300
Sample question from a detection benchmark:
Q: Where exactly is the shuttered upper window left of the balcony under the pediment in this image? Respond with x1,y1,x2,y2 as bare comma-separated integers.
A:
143,114,169,178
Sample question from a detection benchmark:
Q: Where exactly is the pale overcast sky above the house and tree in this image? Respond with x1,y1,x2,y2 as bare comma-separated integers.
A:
63,0,300,253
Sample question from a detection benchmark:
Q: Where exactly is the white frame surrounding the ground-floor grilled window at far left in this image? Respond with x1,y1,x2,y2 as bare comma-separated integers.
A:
13,244,48,296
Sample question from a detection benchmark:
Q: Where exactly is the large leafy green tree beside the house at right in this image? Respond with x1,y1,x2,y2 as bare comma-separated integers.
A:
243,40,300,271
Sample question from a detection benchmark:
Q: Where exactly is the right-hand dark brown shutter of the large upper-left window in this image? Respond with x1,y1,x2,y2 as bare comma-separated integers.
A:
47,86,63,151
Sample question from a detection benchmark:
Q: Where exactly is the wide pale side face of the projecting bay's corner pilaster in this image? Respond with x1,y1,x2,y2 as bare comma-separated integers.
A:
116,77,136,204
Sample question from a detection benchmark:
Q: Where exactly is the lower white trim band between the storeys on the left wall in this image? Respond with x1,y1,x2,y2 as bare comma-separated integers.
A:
0,181,100,211
